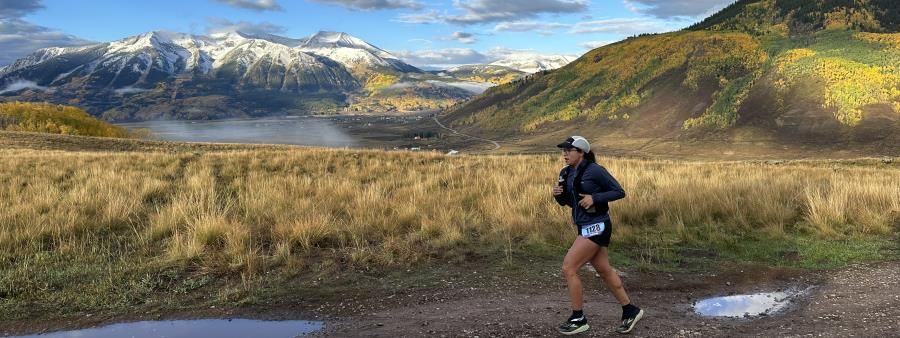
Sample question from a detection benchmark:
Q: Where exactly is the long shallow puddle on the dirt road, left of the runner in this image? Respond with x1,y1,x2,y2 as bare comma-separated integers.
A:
10,319,324,338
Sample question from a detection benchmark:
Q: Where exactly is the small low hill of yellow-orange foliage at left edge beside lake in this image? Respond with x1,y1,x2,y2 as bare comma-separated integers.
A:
0,102,129,137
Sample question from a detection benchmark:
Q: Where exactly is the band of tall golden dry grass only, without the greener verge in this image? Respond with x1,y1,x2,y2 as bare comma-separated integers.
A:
0,148,900,273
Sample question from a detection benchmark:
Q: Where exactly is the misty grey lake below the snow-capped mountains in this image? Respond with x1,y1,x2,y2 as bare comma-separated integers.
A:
118,117,359,147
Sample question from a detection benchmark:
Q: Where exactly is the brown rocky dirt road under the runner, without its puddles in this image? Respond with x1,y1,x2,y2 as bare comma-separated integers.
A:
0,262,900,337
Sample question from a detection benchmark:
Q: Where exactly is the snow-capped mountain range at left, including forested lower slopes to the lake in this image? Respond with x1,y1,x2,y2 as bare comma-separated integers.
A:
0,31,471,120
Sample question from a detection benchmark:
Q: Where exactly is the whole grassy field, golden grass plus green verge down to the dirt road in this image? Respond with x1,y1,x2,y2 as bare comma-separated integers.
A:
0,133,900,319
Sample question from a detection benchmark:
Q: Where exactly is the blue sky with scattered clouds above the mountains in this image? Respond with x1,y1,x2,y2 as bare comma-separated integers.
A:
0,0,731,66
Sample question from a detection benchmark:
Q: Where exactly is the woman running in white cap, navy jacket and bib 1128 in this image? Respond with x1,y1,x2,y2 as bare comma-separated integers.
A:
553,136,644,335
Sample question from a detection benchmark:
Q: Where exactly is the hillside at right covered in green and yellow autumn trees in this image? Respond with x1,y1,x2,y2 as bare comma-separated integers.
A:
447,0,900,149
